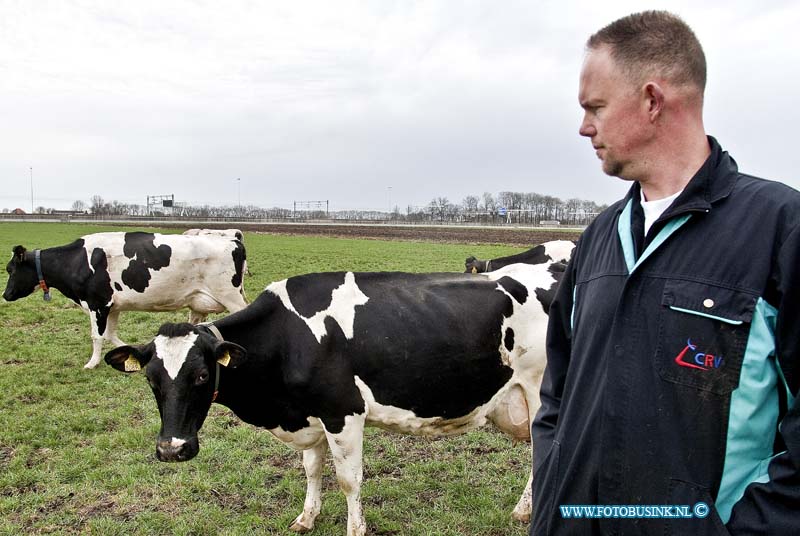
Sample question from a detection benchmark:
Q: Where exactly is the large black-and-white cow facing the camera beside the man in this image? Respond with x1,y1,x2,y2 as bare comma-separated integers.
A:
105,264,557,536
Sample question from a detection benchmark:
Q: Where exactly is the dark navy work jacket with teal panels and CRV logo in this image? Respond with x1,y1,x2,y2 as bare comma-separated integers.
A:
531,138,800,536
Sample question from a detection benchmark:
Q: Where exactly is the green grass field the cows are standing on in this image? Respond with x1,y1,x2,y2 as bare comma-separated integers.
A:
0,223,530,536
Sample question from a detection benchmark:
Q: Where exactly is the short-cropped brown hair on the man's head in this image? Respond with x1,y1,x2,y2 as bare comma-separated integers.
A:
586,11,706,95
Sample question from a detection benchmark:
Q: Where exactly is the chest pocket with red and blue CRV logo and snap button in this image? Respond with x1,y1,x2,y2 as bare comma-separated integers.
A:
655,279,757,395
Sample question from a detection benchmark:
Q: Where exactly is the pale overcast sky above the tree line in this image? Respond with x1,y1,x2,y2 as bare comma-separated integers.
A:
0,0,800,211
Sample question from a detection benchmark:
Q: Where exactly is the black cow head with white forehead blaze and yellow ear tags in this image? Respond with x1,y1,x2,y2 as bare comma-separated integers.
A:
105,324,247,462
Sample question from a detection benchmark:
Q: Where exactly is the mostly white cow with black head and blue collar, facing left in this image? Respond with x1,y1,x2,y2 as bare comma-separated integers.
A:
3,232,247,368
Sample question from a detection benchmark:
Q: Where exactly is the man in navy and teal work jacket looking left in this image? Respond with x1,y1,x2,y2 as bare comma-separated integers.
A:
531,12,800,535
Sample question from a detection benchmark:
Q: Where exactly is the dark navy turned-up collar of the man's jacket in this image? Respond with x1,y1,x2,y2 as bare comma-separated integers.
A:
618,136,739,221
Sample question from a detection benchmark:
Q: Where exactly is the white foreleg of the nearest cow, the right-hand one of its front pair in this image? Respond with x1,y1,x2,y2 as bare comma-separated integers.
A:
323,413,367,536
